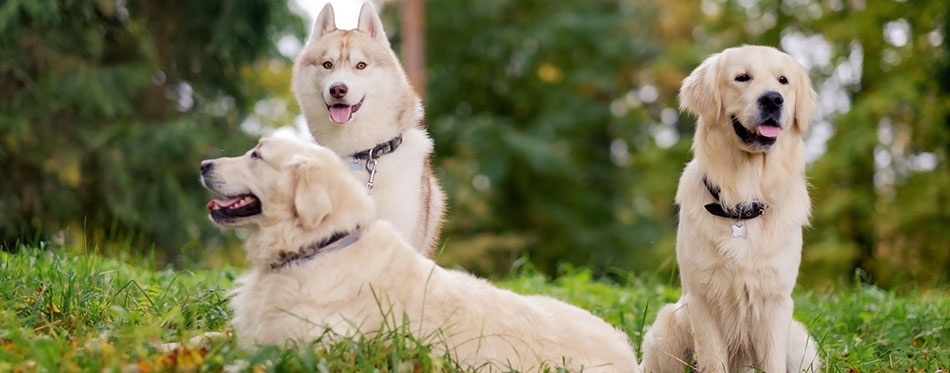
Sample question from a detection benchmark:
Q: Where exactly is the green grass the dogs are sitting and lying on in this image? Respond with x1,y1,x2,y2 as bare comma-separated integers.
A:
0,248,950,372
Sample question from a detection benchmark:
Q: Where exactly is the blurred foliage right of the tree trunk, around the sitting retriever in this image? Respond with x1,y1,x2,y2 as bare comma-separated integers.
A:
418,0,950,286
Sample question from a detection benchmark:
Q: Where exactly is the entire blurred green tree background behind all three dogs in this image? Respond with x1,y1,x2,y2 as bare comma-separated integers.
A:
0,0,950,286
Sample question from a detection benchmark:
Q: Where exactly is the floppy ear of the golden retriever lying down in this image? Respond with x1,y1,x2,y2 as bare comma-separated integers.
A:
290,156,333,228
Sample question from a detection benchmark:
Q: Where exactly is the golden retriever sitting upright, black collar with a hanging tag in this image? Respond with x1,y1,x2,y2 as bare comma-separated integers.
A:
642,46,819,373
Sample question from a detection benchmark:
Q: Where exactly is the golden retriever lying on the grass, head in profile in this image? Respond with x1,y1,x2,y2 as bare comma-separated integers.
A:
201,138,639,372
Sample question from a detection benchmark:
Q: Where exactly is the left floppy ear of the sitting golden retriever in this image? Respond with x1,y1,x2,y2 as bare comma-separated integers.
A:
680,53,722,123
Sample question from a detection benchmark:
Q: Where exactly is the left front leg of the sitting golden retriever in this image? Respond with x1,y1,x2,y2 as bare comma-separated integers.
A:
683,295,729,373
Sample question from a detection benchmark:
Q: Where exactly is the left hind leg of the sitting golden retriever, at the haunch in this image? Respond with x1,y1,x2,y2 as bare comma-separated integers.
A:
641,303,693,373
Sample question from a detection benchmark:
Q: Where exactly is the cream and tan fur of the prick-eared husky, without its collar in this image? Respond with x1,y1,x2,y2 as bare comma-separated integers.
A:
292,3,445,256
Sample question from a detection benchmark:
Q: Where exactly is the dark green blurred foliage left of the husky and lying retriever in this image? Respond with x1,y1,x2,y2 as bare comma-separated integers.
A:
0,0,305,260
